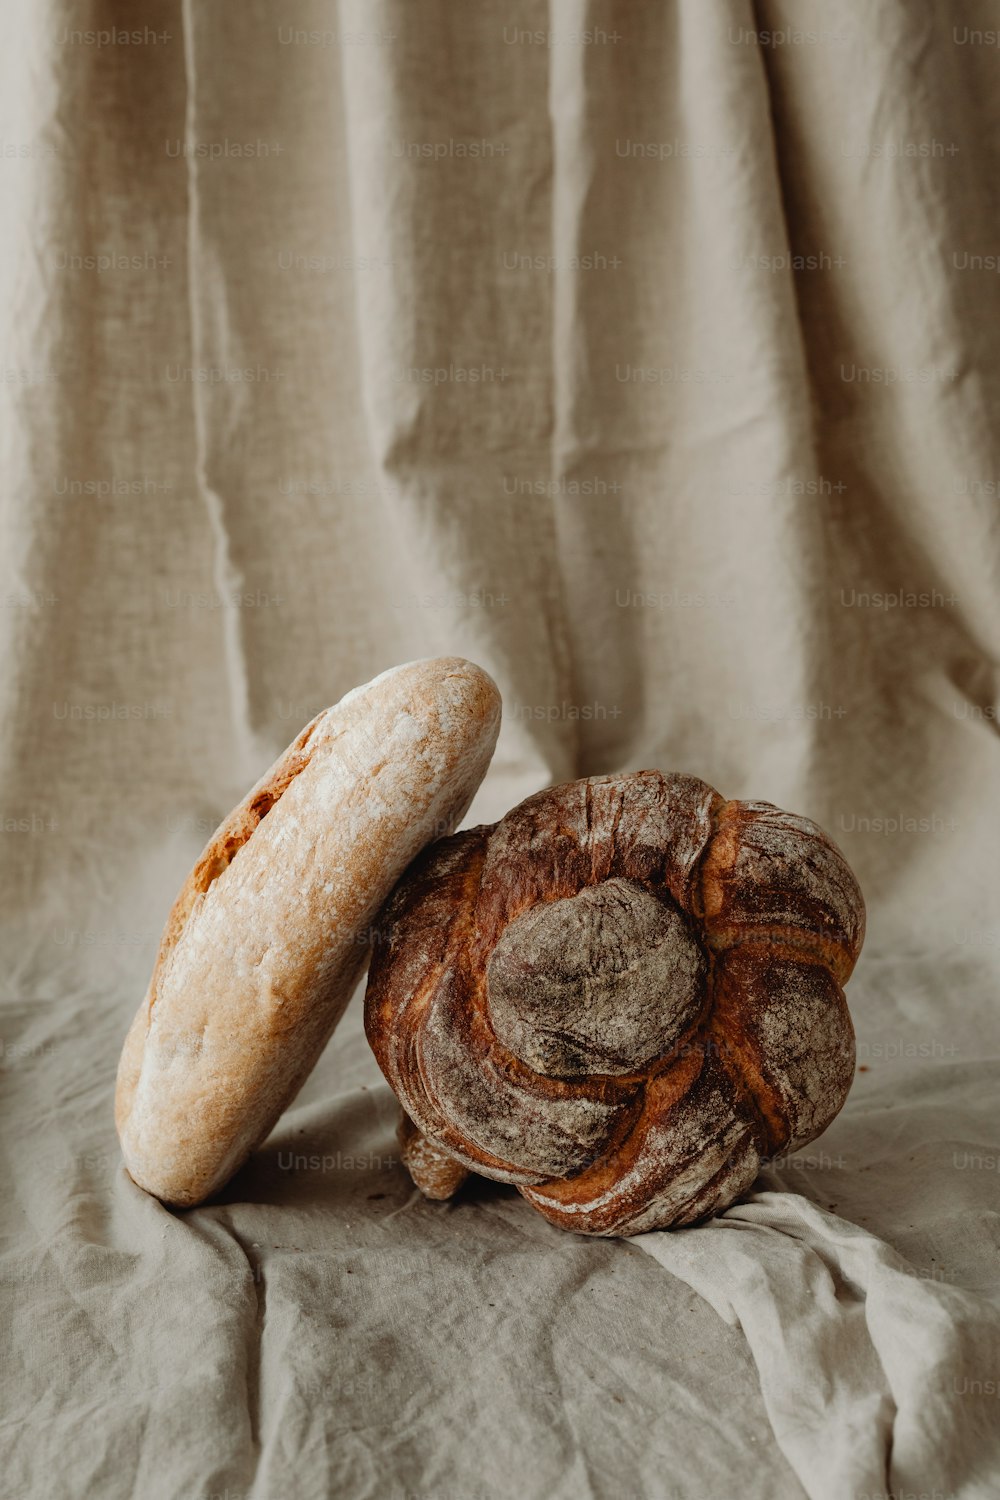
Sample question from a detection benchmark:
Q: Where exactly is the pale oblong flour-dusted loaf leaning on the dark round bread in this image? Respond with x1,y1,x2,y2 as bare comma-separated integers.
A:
115,657,501,1206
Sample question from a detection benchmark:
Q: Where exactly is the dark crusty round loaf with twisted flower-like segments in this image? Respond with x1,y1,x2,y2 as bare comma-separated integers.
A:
366,771,865,1235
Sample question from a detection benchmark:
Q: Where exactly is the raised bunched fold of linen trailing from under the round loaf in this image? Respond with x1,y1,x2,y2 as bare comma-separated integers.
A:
630,1173,1000,1500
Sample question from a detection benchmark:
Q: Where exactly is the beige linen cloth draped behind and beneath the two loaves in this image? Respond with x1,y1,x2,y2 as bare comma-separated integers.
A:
0,0,1000,1500
